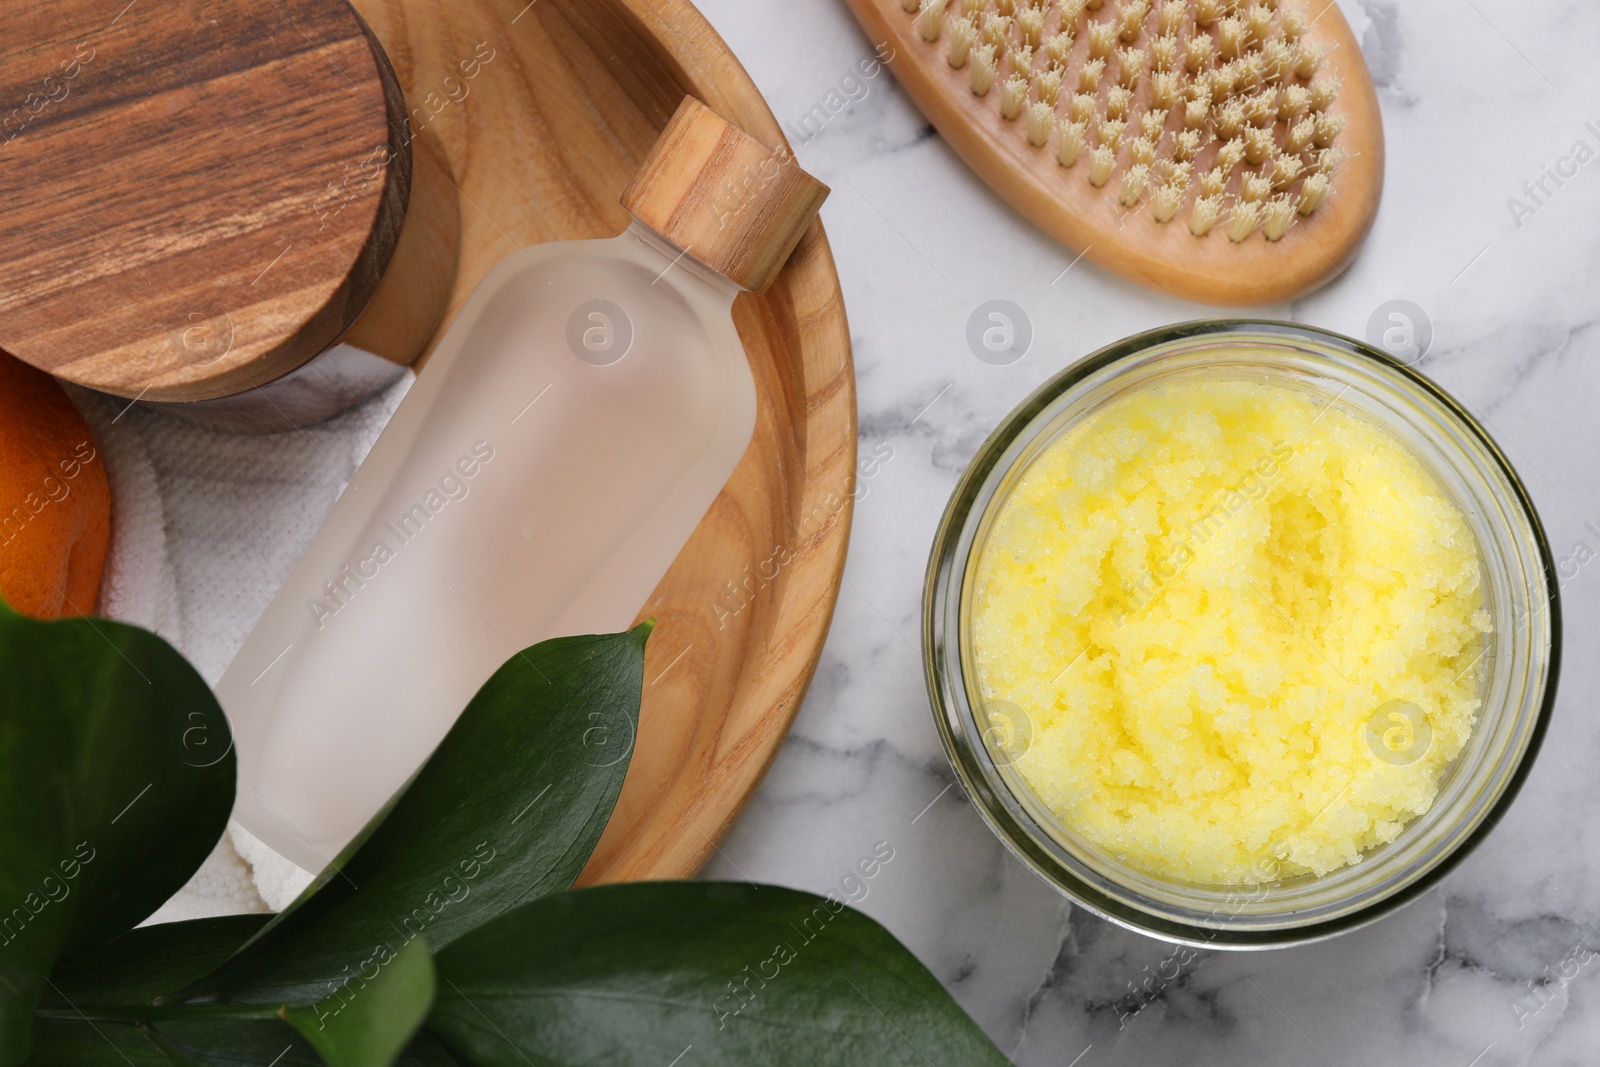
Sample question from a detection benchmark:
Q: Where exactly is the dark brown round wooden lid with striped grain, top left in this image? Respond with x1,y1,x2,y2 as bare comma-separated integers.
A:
0,0,448,403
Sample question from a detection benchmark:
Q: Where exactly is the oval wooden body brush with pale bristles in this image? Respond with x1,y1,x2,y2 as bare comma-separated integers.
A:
850,0,1384,304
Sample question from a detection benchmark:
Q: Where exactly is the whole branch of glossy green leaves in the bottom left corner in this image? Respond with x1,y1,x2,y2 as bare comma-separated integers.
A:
0,605,1006,1067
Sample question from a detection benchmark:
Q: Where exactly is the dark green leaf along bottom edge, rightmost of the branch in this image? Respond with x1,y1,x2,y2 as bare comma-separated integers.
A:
427,881,1006,1067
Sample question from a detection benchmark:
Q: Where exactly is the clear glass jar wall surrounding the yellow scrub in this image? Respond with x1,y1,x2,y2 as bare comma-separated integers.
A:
923,320,1560,949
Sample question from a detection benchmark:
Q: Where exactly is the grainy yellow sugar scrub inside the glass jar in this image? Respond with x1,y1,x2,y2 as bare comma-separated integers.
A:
971,381,1490,885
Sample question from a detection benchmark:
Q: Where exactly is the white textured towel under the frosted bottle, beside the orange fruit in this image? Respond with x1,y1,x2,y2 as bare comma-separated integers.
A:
67,373,414,923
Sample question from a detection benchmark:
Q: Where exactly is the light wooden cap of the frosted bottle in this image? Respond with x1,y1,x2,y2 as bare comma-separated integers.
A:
622,96,829,293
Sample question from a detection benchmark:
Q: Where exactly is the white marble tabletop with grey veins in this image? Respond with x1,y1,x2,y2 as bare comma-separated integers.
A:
701,0,1600,1067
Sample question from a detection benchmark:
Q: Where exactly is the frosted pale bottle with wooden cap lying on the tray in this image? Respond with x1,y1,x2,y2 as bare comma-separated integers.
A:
218,99,827,870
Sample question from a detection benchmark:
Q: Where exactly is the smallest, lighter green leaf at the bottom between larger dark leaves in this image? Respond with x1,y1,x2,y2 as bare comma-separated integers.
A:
283,937,434,1067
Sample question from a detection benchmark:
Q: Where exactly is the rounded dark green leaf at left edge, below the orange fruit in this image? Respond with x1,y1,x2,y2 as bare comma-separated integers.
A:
0,606,234,1067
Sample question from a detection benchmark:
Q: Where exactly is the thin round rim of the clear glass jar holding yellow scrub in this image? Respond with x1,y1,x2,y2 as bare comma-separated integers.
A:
923,318,1562,949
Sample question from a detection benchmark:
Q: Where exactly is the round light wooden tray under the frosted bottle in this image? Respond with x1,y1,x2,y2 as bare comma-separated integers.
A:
344,0,856,883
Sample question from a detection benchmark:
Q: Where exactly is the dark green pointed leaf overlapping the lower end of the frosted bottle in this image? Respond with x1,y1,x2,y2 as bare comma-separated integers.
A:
187,622,651,1005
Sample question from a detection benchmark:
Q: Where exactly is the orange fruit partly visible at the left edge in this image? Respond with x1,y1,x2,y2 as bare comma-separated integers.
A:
0,352,110,619
